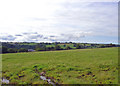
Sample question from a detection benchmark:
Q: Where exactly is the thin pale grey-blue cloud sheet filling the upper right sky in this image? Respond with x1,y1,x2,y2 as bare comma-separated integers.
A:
55,2,118,36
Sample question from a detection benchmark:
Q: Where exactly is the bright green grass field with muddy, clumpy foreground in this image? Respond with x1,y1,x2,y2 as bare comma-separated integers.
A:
2,48,118,84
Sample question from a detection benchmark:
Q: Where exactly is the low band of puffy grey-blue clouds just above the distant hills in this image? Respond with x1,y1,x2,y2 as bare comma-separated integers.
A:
0,32,91,42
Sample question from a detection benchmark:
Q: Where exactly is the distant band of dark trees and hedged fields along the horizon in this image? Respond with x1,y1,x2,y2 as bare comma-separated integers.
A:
0,42,120,53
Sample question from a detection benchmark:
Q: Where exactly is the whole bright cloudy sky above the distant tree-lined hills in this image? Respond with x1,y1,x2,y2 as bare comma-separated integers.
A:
0,0,118,43
